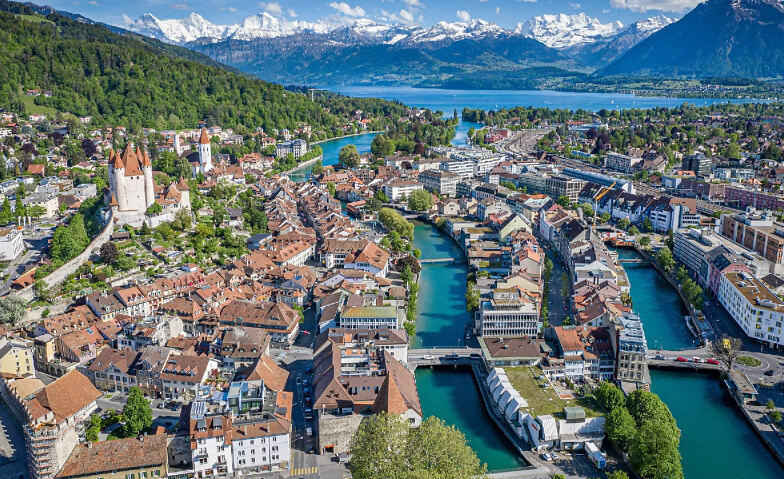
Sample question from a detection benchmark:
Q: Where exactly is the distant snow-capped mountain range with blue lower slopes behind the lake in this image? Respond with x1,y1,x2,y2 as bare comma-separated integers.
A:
124,12,674,88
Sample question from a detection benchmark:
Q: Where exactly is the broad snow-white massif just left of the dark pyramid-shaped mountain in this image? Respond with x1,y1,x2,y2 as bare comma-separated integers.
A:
515,13,623,50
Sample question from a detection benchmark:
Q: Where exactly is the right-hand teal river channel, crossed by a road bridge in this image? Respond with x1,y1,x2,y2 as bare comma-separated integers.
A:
618,249,784,479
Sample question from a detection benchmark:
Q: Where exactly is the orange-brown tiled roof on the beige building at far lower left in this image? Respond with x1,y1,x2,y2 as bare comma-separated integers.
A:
25,370,101,422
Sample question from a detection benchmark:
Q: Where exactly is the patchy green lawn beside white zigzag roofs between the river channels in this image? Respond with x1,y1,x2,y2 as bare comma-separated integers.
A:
504,366,605,419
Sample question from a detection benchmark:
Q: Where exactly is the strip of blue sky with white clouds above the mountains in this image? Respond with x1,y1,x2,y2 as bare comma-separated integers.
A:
43,0,699,27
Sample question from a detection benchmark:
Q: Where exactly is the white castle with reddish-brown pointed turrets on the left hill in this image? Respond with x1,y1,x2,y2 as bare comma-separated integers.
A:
105,143,191,226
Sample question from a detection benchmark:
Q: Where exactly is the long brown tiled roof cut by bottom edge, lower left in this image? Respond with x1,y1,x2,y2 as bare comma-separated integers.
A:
56,434,168,478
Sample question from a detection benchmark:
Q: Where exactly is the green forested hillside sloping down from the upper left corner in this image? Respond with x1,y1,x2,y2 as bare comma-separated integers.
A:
0,0,404,136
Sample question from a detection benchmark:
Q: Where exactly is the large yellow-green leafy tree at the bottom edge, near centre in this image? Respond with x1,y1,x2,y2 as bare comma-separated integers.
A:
350,413,487,479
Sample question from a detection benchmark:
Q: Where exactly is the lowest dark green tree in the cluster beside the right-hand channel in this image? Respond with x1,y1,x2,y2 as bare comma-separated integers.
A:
629,421,683,479
